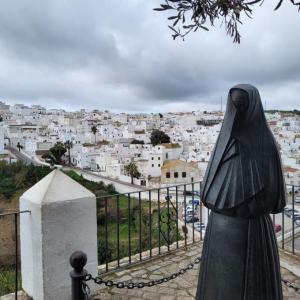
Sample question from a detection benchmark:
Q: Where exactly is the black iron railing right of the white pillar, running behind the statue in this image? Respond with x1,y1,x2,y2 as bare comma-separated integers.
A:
97,182,300,273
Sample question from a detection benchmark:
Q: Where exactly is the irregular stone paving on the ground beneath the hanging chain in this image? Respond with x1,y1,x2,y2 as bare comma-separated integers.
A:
93,244,300,300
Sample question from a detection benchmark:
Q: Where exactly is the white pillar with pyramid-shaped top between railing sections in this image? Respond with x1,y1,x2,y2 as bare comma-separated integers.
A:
20,170,98,300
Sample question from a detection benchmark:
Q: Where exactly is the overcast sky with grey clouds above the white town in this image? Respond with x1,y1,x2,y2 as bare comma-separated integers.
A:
0,0,300,112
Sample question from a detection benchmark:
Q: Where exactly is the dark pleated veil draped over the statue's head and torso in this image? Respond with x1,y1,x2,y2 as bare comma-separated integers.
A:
201,84,286,215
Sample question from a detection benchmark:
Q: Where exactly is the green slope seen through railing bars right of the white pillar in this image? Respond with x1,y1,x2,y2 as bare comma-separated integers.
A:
66,171,183,264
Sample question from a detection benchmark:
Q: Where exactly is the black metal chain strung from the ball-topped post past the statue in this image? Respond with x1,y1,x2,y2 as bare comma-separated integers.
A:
82,257,300,300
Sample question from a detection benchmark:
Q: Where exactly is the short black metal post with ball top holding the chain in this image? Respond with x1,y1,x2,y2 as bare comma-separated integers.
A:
70,251,87,300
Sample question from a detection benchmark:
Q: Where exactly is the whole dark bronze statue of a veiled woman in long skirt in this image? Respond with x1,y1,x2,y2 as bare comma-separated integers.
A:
196,84,286,300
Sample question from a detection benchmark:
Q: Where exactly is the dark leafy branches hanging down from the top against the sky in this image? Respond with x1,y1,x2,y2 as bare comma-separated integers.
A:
154,0,300,43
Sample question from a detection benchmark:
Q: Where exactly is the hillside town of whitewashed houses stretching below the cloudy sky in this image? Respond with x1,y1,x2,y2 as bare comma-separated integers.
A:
0,102,300,188
